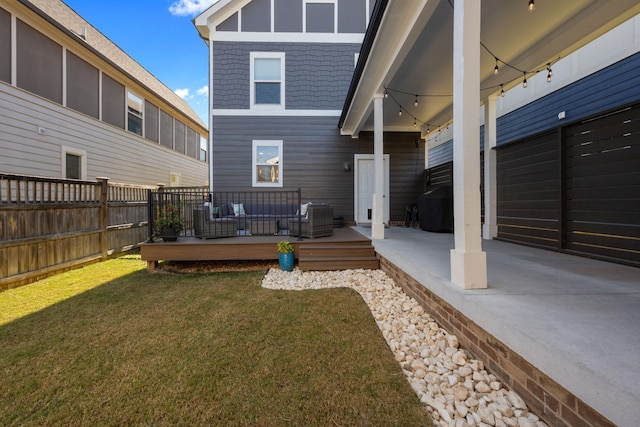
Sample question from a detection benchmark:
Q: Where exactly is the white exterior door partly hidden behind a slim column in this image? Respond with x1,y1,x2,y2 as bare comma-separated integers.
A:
354,154,389,224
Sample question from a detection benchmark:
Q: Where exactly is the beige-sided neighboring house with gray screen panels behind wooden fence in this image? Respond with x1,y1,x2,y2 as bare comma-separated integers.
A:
0,0,208,186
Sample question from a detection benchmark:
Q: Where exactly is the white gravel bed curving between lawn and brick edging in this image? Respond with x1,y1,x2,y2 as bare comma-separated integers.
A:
262,268,546,427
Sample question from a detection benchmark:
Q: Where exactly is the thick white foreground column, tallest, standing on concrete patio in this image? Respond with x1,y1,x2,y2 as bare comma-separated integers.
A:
451,0,487,289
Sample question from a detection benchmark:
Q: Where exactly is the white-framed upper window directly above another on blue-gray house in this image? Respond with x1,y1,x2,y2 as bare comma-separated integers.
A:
250,52,284,108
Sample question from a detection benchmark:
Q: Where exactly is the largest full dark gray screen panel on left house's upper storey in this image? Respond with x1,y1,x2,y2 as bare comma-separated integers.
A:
16,19,62,104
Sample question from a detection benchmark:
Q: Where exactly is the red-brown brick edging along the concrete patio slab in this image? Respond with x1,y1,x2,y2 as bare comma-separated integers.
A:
377,254,615,427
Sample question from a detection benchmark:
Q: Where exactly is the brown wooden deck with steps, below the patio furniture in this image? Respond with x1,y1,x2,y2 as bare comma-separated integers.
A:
140,227,379,271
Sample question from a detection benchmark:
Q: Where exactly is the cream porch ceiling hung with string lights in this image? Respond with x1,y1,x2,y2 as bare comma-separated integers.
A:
342,0,640,135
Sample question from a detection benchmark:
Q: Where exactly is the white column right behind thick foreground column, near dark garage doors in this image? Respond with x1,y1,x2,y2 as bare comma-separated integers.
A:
482,95,498,240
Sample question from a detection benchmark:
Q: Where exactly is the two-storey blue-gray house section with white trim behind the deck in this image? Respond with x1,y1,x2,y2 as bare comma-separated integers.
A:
195,0,425,223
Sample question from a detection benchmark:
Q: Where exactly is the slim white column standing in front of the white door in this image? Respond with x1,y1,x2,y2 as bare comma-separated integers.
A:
371,95,384,239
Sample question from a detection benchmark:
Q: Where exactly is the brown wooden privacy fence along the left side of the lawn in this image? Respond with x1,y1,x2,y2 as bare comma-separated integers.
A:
0,174,156,289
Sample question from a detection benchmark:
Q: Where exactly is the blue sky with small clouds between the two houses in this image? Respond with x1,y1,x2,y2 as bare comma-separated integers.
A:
63,0,216,123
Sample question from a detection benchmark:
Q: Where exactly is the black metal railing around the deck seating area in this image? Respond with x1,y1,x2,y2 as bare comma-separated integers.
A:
148,187,302,241
